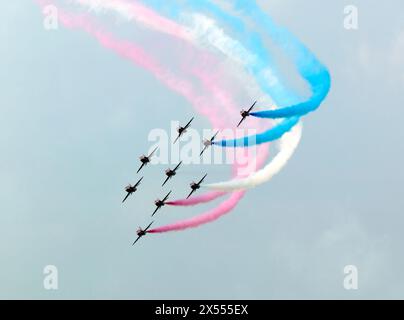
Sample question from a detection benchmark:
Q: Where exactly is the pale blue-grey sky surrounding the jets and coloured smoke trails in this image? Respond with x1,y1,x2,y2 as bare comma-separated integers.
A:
0,0,404,299
